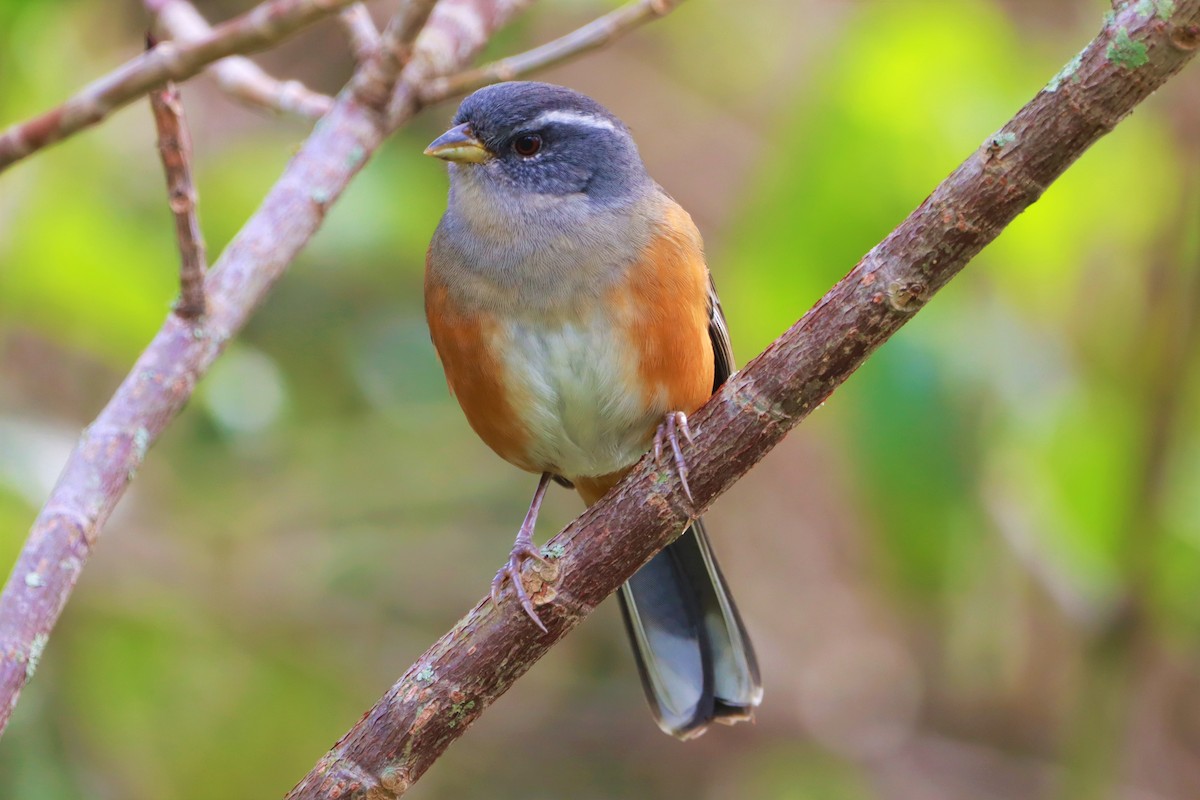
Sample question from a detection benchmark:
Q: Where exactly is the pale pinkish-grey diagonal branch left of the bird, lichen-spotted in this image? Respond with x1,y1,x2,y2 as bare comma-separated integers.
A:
0,0,530,732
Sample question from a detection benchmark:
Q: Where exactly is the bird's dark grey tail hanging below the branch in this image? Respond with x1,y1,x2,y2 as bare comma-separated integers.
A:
620,519,762,739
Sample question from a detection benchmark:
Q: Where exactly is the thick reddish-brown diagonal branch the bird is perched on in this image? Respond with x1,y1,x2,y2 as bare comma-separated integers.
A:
288,6,1200,800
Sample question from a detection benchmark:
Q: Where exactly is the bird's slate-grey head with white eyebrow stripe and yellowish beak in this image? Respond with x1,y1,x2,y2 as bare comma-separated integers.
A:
425,82,650,205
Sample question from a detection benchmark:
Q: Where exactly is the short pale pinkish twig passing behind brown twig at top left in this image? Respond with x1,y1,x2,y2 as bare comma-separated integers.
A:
152,0,334,119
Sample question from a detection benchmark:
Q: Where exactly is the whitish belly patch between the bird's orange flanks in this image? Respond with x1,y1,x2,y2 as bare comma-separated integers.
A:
496,312,670,479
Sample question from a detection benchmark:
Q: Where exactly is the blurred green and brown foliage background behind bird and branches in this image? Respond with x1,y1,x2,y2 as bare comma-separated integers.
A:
0,0,1200,800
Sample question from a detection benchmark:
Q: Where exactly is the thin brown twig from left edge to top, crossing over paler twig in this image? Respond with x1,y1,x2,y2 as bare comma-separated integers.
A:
0,0,354,170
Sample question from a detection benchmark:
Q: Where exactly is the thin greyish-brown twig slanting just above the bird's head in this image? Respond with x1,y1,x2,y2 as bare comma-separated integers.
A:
421,0,683,104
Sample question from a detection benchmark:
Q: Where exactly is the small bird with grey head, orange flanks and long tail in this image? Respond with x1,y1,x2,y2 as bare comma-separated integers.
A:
425,82,762,739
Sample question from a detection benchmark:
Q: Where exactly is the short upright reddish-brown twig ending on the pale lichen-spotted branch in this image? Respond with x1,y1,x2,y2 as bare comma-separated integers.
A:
150,74,208,319
